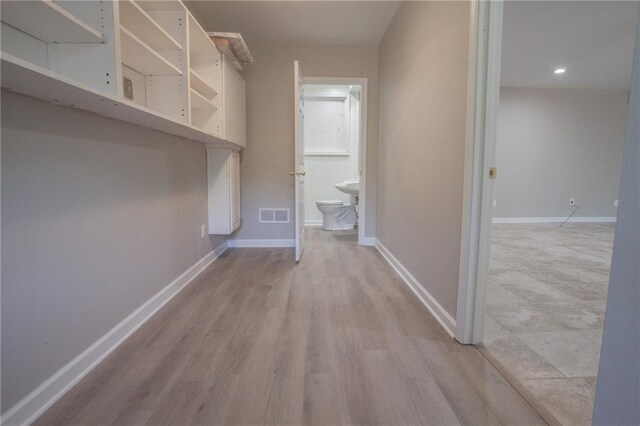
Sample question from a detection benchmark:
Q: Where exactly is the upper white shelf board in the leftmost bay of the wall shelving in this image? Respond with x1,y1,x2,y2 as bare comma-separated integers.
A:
0,0,103,43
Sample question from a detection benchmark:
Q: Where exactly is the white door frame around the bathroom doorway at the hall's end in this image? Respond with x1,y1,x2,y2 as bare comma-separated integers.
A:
302,76,373,246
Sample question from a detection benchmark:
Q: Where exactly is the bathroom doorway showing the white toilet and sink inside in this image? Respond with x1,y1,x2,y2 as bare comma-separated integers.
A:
302,77,366,244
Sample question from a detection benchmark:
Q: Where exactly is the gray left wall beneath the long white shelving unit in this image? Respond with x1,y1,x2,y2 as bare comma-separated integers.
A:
1,91,225,411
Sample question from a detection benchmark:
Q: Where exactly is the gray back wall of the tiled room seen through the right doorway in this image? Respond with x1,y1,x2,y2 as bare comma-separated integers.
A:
494,88,628,218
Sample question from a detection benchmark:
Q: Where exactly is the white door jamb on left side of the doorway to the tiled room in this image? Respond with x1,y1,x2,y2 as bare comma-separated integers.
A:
455,0,503,344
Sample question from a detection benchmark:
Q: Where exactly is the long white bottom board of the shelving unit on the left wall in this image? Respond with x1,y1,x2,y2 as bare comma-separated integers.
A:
0,52,238,151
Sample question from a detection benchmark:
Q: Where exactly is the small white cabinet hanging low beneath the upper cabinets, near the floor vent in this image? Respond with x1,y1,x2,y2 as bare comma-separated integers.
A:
207,147,241,235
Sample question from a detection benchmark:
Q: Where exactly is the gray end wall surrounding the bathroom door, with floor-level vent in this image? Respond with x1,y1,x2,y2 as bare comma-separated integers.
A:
232,44,378,239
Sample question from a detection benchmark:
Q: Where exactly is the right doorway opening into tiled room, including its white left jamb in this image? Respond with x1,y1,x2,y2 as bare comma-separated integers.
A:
457,2,638,424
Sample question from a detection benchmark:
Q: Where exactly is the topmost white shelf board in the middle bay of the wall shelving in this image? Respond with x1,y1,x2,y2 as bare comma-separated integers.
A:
120,0,182,50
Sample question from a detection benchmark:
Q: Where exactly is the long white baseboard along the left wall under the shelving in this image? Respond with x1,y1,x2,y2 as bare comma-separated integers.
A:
1,242,227,425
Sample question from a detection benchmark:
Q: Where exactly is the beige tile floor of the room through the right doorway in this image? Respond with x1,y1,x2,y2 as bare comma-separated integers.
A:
485,224,615,425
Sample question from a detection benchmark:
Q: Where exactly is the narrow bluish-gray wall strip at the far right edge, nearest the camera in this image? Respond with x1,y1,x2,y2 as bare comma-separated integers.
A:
593,12,640,425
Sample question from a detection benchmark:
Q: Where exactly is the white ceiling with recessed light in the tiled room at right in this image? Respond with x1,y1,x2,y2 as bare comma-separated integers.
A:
501,1,639,88
